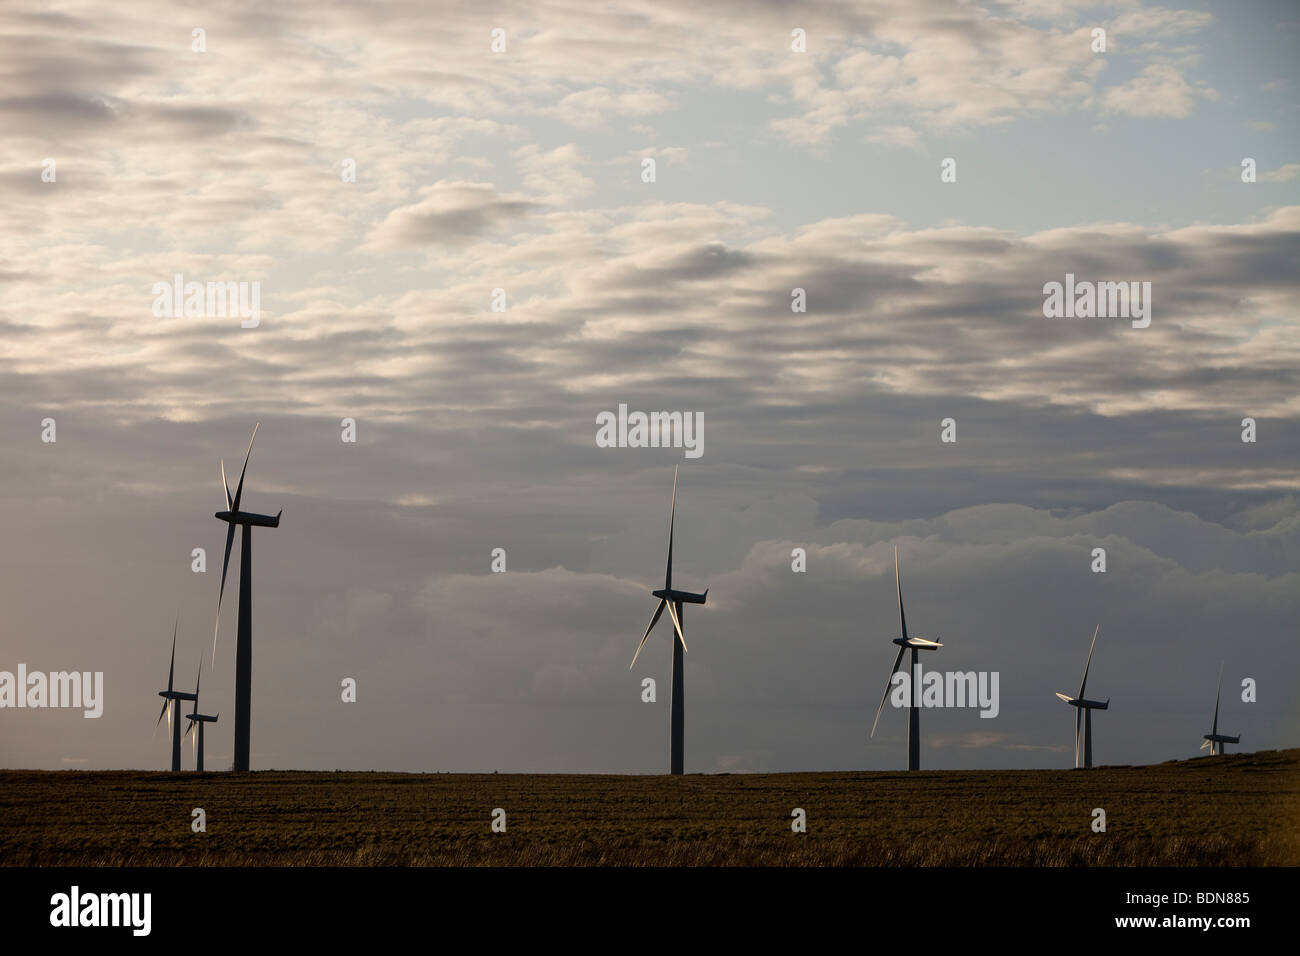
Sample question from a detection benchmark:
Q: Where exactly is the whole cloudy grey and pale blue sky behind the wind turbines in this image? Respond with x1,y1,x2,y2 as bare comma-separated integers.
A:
0,0,1300,773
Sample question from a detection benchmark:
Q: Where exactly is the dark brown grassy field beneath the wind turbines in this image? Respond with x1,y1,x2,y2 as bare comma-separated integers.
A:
0,750,1300,866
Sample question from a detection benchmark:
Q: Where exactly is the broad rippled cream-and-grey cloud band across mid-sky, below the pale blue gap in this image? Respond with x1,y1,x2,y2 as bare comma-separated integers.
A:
0,199,1300,455
